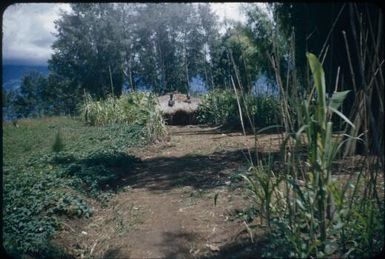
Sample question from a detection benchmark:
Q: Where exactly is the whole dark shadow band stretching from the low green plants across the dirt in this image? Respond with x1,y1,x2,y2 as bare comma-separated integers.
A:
52,146,279,195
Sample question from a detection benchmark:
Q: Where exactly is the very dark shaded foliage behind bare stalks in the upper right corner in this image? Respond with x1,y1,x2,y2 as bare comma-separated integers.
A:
272,2,385,159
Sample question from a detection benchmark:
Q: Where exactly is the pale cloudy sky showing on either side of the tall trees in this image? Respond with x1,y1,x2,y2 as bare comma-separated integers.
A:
2,3,258,65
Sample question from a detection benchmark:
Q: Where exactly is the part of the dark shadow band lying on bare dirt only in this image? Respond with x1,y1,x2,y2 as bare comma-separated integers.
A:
126,149,279,191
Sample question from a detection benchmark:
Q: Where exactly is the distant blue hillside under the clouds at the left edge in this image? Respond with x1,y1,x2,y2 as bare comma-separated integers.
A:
3,65,48,91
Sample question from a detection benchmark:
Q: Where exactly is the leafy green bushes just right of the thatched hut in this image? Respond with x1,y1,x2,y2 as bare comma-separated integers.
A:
197,90,279,128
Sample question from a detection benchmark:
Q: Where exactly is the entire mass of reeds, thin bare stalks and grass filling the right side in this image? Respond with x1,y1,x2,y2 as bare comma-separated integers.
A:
233,4,385,258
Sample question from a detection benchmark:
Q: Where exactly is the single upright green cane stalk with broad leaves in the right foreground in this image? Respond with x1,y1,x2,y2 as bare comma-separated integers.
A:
288,53,354,254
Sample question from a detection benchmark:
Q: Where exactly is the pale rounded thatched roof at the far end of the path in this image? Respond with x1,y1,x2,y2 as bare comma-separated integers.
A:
157,94,201,114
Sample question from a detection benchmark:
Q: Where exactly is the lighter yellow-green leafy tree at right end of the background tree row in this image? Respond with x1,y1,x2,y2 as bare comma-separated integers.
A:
218,3,287,93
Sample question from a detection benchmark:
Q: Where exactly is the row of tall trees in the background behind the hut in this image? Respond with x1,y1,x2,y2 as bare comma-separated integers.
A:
6,3,283,117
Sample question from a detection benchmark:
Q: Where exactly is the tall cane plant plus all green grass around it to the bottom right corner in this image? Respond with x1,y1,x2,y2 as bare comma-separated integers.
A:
238,53,384,258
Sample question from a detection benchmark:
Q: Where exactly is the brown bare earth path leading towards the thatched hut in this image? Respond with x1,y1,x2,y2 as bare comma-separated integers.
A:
57,126,279,258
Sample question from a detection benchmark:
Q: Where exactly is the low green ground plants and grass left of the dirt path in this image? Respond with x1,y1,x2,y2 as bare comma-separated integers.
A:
3,117,144,257
